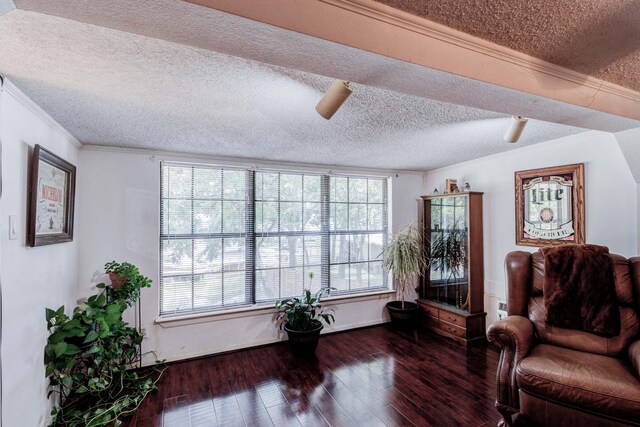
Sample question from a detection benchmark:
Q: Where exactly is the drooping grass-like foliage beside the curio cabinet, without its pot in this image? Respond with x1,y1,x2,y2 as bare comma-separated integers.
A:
381,223,429,310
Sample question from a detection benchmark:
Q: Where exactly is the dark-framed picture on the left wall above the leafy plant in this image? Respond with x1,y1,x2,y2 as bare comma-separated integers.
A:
27,144,76,247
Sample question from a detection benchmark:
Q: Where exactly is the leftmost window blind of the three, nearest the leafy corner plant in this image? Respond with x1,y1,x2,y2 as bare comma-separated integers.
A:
160,162,254,315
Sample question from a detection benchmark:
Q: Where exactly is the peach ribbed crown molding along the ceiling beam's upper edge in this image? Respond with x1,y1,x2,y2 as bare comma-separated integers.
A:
330,0,640,102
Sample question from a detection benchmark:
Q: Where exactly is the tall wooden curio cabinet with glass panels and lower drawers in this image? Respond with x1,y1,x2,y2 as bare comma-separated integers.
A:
418,192,487,344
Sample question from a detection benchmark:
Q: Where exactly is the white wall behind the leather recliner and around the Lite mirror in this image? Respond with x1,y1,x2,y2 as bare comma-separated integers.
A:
425,131,638,325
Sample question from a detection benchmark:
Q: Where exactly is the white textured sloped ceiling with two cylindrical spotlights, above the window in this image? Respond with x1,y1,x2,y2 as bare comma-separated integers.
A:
0,5,582,169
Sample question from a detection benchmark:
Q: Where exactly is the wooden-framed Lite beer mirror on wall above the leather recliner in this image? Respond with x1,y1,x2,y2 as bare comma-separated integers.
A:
515,163,585,247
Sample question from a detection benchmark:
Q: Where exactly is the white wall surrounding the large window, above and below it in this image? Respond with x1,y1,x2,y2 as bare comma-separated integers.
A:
77,147,423,362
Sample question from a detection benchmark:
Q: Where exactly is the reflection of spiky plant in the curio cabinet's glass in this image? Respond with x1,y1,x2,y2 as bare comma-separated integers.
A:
430,222,468,308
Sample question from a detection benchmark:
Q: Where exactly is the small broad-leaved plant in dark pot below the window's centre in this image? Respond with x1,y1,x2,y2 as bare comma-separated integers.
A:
276,273,335,356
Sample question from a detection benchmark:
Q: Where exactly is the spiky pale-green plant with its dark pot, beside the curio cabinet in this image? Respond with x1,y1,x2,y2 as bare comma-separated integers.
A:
381,224,429,325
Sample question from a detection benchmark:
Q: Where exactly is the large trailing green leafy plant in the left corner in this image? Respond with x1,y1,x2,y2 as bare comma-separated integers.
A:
44,263,164,427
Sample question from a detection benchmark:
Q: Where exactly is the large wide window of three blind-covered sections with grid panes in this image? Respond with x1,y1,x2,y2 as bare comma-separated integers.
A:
160,162,387,315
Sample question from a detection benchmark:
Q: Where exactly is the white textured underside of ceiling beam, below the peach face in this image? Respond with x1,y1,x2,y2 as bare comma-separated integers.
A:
11,0,640,132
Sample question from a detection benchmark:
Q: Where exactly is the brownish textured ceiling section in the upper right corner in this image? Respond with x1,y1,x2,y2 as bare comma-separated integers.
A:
376,0,640,91
